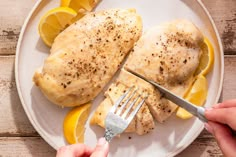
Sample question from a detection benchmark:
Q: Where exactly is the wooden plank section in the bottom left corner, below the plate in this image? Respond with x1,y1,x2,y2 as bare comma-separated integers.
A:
0,137,56,157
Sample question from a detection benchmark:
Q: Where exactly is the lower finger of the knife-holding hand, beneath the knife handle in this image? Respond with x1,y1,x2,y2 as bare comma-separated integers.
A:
207,122,236,156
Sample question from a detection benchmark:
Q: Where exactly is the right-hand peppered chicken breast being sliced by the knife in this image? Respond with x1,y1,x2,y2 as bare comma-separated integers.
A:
124,20,204,122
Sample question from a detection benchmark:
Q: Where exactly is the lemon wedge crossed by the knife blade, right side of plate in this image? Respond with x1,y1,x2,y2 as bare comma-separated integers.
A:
176,75,208,119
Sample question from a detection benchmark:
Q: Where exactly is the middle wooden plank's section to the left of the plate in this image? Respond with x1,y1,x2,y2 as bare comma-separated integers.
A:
0,56,37,136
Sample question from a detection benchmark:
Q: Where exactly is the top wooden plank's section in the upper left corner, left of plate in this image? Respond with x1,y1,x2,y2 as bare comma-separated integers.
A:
0,0,37,55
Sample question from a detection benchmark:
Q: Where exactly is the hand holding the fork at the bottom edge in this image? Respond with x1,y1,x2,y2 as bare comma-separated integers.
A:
56,138,109,157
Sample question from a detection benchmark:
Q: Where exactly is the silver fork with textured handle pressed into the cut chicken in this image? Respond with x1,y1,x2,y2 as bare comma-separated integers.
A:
104,86,147,142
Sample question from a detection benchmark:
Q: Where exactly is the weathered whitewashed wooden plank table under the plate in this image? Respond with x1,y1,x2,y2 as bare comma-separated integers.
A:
0,0,236,157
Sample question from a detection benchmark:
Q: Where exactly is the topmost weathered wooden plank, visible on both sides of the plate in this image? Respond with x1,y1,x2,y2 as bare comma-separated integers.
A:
0,0,236,55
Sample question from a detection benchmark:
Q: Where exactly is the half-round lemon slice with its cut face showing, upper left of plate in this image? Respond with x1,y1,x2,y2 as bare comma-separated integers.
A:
38,7,77,47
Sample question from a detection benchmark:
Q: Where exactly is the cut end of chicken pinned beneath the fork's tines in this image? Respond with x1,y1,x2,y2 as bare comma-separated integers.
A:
91,82,154,135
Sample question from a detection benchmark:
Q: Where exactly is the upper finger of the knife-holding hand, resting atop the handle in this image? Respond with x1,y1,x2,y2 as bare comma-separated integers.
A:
205,107,236,130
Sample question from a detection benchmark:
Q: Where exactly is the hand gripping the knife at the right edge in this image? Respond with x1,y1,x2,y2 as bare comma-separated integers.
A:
205,99,236,157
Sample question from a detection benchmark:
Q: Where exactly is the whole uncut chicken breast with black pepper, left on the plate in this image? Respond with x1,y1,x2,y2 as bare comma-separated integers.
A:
33,9,142,106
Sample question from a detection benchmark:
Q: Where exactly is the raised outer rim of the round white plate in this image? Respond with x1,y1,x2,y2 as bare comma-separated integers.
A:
14,0,224,156
